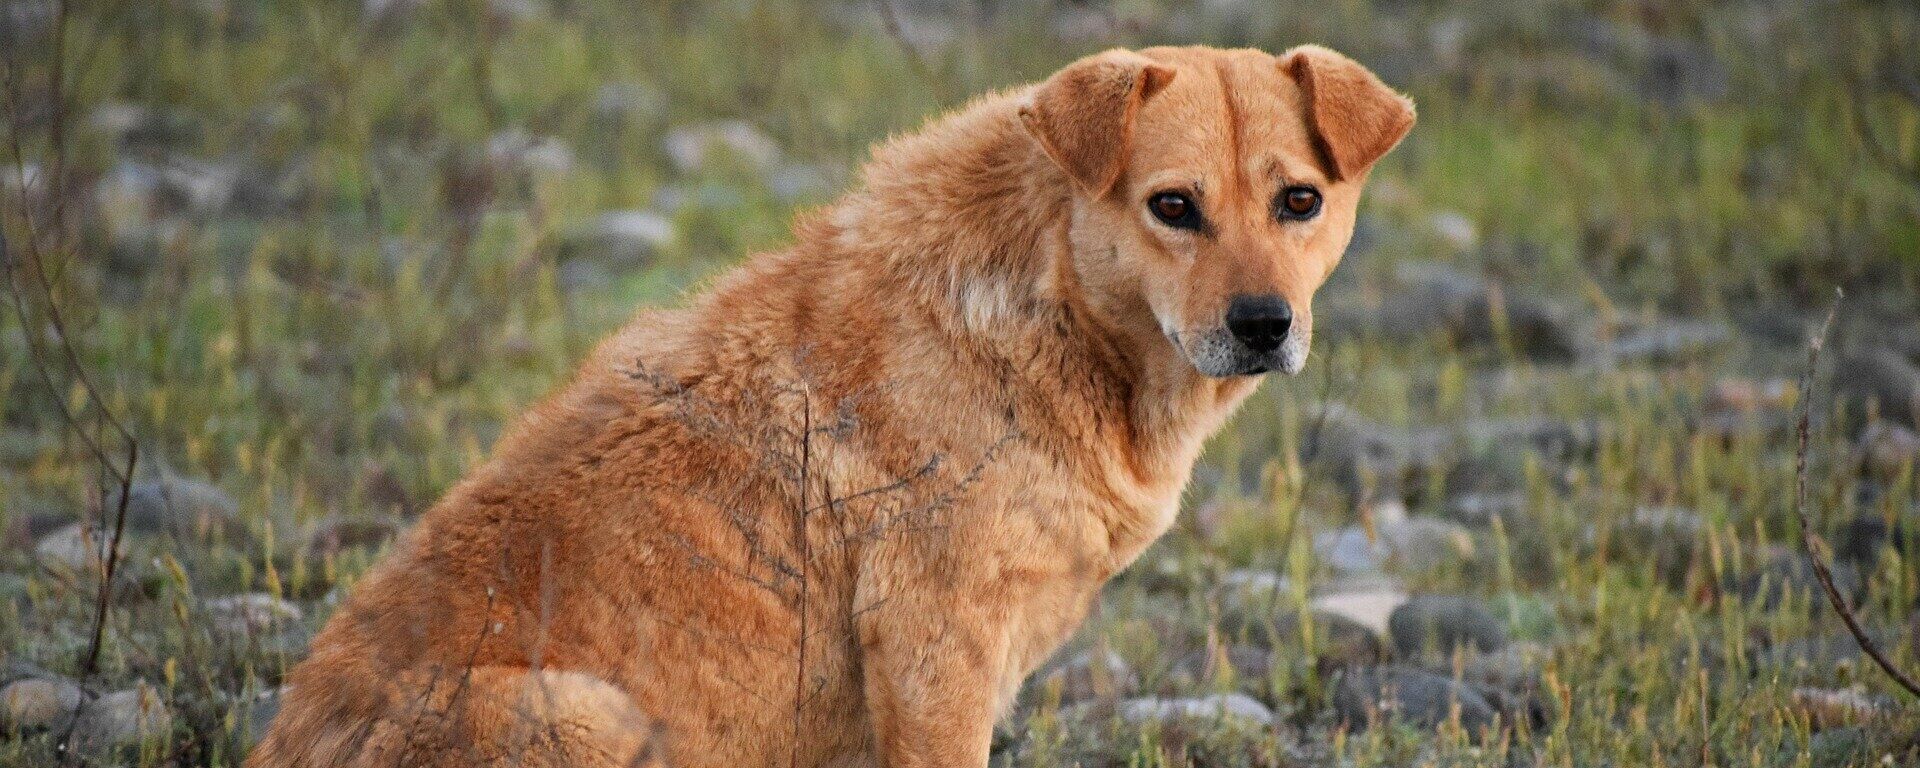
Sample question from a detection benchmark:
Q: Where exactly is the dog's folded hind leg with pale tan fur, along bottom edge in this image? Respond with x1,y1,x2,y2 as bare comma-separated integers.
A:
248,666,660,768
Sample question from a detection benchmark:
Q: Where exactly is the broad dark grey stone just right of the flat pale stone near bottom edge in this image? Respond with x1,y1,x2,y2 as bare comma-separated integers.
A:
1332,666,1498,733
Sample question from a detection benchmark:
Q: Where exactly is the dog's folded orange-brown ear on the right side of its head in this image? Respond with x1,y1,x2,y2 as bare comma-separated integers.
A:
1281,46,1413,179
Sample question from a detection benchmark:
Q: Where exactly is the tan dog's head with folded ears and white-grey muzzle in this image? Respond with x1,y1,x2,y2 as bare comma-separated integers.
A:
1020,46,1413,376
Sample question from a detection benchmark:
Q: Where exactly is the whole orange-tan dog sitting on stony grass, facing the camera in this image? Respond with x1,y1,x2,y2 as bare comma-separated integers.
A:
248,46,1415,768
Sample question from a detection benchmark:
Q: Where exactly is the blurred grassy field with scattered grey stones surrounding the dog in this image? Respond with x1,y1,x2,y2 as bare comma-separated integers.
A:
0,0,1920,766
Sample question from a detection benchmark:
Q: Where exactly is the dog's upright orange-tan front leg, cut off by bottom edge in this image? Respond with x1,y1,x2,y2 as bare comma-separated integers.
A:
854,547,1008,768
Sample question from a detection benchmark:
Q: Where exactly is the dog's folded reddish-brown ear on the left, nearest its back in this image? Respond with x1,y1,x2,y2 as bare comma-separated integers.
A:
1020,48,1173,198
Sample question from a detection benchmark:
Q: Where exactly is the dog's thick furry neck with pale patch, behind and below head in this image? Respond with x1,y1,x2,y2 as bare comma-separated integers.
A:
828,94,1256,505
